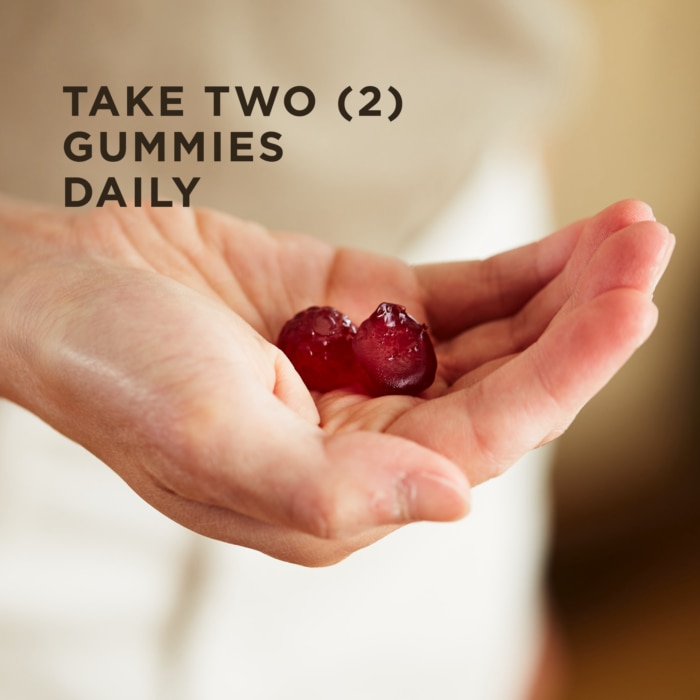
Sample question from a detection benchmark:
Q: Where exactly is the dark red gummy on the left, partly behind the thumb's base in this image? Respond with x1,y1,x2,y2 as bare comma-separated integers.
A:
277,306,358,391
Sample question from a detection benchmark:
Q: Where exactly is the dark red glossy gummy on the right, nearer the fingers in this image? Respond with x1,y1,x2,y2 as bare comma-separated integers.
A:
352,302,437,395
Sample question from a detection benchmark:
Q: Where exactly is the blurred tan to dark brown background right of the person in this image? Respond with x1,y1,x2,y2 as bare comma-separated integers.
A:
549,0,700,700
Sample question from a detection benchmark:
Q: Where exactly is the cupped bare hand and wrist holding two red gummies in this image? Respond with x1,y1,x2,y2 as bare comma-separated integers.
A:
0,198,674,566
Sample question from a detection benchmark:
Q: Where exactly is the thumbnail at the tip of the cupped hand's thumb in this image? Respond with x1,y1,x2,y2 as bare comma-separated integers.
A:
397,472,469,522
